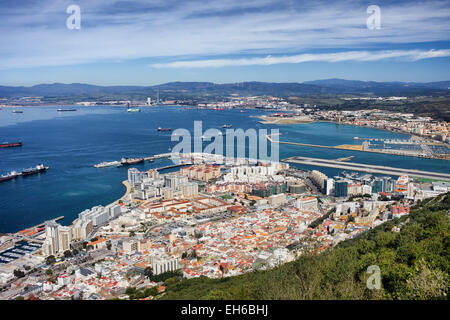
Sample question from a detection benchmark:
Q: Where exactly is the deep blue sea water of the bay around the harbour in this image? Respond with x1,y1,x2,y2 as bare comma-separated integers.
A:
0,106,450,232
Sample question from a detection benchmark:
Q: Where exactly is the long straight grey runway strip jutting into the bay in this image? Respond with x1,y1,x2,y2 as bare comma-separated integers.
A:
281,157,450,181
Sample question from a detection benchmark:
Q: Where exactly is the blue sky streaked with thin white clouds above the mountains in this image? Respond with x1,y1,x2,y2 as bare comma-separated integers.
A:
0,0,450,85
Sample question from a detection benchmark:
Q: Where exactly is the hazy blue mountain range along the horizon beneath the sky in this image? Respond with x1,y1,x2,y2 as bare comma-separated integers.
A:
0,79,450,98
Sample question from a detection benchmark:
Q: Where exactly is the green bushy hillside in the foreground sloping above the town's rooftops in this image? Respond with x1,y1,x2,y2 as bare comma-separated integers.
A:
161,193,450,300
